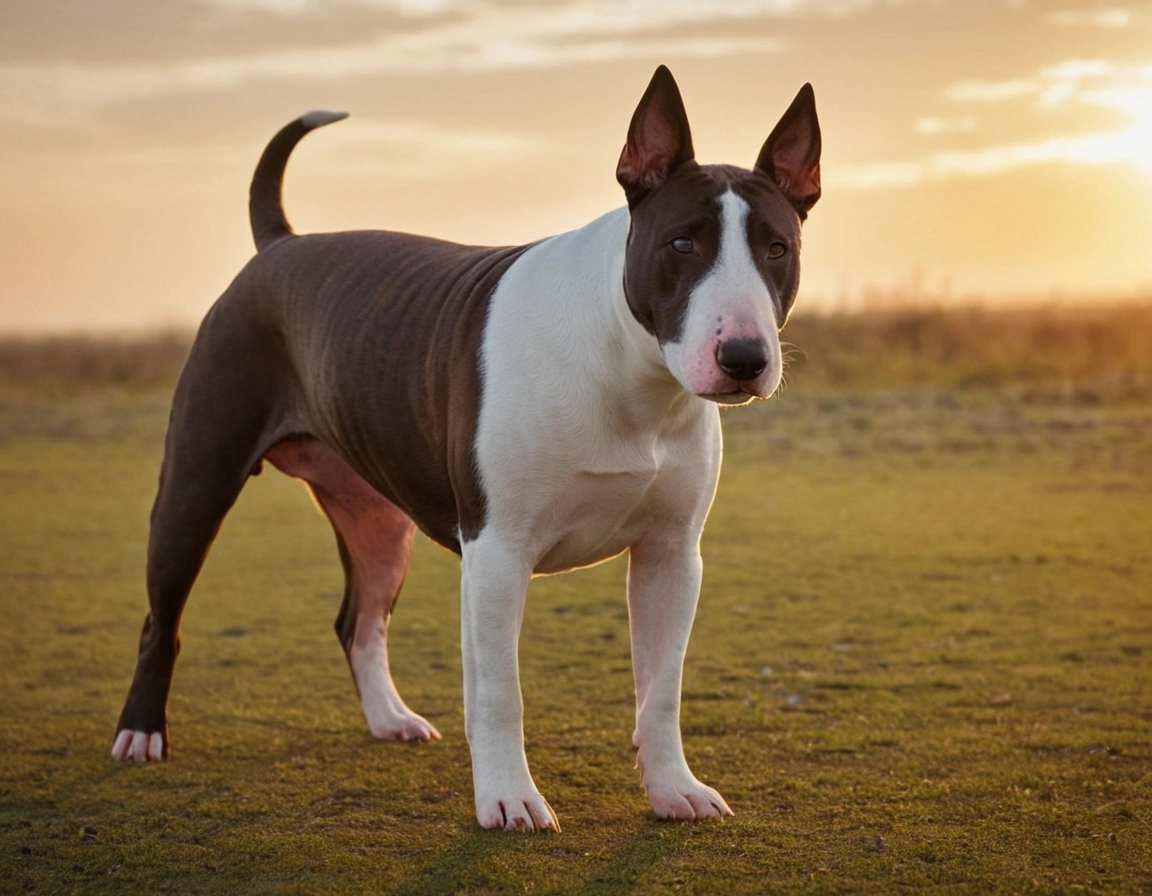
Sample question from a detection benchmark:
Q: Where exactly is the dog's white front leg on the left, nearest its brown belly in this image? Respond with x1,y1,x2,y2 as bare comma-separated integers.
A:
461,534,560,833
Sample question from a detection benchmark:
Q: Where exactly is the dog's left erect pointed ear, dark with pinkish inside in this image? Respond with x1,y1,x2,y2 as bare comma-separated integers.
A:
616,66,695,207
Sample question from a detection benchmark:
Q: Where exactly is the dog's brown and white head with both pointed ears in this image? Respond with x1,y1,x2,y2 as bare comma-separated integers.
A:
616,66,820,404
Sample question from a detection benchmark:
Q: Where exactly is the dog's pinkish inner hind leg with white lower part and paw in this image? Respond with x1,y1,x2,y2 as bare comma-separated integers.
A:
265,438,440,741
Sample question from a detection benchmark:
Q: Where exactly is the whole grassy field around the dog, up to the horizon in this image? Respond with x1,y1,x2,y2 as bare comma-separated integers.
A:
0,306,1152,894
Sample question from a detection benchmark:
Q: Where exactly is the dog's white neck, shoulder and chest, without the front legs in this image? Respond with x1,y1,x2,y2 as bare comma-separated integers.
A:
475,207,720,574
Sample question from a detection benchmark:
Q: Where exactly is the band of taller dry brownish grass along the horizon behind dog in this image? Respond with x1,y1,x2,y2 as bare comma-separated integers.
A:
0,298,1152,397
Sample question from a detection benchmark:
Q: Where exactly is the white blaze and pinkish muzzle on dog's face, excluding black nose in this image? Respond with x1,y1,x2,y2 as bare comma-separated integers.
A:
664,190,783,402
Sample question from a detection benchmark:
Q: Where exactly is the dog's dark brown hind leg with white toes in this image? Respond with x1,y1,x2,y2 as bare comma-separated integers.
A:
112,321,282,762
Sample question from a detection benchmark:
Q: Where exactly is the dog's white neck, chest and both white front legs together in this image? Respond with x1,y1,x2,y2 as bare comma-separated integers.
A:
462,210,728,830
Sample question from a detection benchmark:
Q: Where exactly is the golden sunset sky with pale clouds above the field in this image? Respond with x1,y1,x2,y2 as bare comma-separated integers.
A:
0,0,1152,333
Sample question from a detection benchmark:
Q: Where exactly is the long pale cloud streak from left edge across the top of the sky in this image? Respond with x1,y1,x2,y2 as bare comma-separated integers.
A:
0,0,801,124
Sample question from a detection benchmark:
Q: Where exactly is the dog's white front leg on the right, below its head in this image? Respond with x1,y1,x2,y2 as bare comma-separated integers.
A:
628,532,733,820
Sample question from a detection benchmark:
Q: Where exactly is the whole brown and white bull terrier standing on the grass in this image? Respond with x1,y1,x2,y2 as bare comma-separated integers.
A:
112,66,820,832
